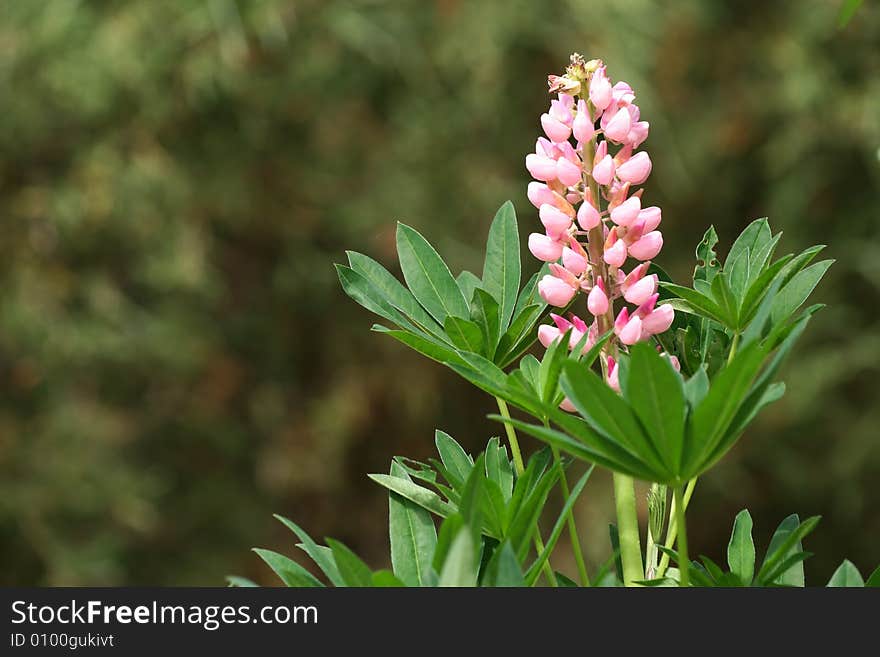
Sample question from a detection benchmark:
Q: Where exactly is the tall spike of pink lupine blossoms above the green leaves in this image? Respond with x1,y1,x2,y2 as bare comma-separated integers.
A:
526,56,677,384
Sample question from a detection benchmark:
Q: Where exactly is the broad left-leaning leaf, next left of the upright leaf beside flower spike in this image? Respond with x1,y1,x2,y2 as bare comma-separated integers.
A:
397,223,470,324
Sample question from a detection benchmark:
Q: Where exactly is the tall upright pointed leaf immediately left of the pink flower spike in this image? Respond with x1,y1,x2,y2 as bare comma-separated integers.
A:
483,201,521,327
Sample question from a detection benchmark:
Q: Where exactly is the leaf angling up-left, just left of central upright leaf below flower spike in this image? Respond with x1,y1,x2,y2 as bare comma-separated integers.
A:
562,361,674,483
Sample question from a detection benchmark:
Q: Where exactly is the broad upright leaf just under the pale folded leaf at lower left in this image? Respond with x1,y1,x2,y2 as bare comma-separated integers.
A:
388,462,437,586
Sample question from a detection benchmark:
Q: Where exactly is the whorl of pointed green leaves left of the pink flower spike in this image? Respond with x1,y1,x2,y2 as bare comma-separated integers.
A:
336,201,545,368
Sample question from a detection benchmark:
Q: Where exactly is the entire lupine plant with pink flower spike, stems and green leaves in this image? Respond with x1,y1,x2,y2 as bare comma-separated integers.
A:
237,54,880,586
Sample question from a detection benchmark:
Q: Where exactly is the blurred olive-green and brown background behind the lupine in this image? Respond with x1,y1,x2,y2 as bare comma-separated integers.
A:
0,0,880,585
